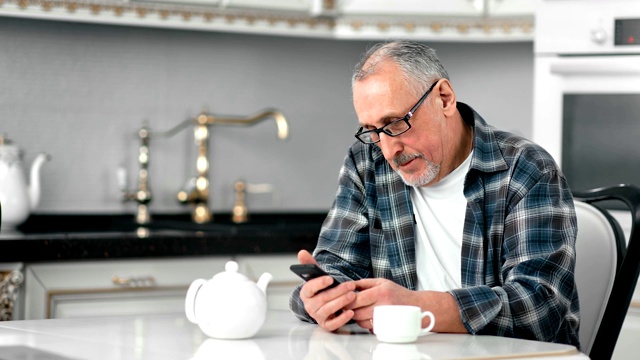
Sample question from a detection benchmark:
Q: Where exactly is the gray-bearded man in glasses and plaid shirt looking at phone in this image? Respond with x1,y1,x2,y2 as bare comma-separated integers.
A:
290,41,579,346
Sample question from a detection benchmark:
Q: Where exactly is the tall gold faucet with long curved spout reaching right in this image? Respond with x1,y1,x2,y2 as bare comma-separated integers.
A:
172,109,289,224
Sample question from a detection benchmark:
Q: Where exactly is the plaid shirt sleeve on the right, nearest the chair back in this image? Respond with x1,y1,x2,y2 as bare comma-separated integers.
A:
450,171,578,342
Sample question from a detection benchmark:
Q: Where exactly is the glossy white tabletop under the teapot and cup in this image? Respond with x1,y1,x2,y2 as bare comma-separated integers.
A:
0,310,588,360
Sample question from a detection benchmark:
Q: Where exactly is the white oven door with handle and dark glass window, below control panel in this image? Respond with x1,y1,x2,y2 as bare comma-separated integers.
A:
533,55,640,191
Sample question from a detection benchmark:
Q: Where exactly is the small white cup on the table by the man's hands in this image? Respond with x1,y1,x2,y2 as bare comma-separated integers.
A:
373,305,436,343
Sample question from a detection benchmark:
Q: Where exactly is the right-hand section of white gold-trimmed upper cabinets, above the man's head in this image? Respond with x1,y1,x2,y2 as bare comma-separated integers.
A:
333,0,537,42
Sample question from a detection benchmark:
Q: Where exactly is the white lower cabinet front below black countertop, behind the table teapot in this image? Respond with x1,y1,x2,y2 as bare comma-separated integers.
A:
24,255,296,319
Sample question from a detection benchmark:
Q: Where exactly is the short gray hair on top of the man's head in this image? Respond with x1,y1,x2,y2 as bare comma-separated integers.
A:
351,40,449,96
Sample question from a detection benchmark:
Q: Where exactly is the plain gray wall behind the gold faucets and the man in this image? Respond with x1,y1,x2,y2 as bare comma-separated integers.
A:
0,17,533,213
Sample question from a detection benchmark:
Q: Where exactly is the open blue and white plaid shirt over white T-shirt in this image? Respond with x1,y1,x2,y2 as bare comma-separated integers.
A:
290,103,579,346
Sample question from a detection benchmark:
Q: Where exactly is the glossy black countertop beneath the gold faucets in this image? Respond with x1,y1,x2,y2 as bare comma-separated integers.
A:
0,213,326,262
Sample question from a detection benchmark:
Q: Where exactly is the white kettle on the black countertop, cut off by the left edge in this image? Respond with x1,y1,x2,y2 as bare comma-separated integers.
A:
0,135,50,232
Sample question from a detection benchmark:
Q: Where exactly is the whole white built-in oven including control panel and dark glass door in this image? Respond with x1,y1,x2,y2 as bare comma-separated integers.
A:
533,0,640,195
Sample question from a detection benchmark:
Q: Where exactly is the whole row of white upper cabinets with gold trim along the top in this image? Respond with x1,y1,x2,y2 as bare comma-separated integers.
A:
0,0,538,42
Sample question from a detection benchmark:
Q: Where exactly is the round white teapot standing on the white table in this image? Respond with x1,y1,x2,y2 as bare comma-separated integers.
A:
185,261,272,339
